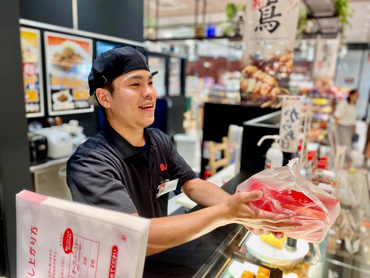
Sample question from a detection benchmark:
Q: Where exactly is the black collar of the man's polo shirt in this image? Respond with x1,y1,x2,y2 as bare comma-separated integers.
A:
103,121,157,159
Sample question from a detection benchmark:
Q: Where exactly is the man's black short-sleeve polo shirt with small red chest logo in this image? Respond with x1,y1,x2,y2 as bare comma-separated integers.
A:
67,124,196,218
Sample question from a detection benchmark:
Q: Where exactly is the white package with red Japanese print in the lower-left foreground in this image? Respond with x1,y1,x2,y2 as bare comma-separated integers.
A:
16,190,150,278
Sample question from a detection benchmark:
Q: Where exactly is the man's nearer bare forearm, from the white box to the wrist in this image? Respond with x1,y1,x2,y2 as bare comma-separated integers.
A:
147,203,229,256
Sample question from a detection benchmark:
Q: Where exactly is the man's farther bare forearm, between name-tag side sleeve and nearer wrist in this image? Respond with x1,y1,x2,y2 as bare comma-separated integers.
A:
182,179,230,207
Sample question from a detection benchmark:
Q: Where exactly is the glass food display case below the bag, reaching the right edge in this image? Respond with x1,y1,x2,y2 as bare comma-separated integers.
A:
194,170,370,278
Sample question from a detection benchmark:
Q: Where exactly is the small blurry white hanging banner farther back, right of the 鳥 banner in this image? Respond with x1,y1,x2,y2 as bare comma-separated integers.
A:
313,38,339,80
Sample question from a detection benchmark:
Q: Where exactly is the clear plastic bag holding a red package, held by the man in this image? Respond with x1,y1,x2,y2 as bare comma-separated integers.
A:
237,158,340,243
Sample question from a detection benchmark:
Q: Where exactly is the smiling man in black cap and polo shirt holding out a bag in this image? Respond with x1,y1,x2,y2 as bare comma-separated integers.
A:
67,47,296,255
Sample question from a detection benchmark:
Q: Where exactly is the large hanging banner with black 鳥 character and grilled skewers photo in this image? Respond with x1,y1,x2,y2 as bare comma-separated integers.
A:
240,0,300,108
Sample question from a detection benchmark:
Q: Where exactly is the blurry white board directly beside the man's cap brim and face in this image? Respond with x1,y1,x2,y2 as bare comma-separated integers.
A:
148,54,166,98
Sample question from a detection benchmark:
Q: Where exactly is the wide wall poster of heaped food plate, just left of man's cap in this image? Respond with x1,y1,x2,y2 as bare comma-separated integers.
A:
45,32,94,116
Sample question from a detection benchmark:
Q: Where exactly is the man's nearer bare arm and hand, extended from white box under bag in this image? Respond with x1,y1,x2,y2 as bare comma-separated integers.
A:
134,191,299,255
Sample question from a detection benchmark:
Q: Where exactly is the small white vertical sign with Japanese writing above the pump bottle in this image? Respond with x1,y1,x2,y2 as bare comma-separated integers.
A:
279,97,302,153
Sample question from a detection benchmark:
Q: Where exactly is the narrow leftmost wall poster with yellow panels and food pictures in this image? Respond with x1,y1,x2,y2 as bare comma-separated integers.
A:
20,27,45,118
